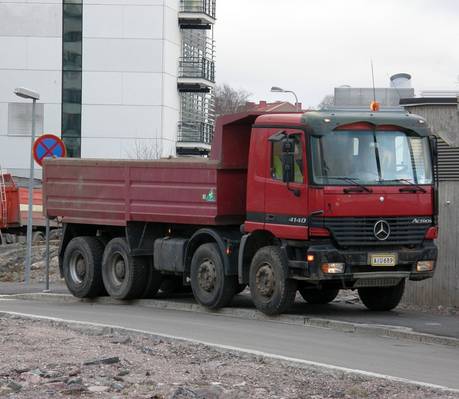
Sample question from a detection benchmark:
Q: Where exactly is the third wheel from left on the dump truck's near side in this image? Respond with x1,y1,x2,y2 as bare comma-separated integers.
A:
190,243,237,309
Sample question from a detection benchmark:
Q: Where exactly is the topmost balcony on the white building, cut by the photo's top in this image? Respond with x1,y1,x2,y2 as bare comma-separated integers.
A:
179,0,216,29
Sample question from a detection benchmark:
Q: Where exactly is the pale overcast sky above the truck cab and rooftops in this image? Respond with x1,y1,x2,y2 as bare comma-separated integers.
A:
215,0,459,107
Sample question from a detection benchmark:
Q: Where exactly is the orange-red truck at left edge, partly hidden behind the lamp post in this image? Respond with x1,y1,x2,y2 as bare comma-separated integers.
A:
0,172,51,245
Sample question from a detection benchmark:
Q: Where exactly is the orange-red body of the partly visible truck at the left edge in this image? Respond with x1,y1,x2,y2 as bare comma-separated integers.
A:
0,174,45,229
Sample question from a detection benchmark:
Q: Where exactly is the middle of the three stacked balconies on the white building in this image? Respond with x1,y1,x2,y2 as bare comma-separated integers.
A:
177,57,215,93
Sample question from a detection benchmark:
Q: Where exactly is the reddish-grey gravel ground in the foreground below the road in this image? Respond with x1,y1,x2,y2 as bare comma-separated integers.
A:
0,316,459,399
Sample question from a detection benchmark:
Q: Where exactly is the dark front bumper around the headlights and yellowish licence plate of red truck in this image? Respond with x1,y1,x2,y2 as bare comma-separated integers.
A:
289,241,438,288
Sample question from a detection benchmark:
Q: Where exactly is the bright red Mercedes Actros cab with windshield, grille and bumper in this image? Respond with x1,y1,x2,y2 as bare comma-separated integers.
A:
243,110,438,310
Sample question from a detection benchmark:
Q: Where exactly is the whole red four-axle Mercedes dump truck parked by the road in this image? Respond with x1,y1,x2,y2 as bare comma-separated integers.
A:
44,111,438,314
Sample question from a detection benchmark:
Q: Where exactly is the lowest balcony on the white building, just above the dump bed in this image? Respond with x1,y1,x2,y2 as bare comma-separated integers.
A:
177,121,214,155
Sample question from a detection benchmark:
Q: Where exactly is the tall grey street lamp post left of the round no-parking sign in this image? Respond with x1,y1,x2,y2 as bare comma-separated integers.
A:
14,87,40,286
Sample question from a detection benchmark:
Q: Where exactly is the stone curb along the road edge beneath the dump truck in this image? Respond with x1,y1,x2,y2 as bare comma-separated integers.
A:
0,293,459,347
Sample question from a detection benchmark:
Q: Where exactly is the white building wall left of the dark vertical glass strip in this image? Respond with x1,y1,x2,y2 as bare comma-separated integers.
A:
0,0,62,176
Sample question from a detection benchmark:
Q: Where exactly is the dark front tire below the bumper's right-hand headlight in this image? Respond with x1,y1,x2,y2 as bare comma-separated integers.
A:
358,279,405,310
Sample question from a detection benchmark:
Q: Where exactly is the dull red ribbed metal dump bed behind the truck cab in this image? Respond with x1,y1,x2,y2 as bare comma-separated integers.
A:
43,157,246,226
